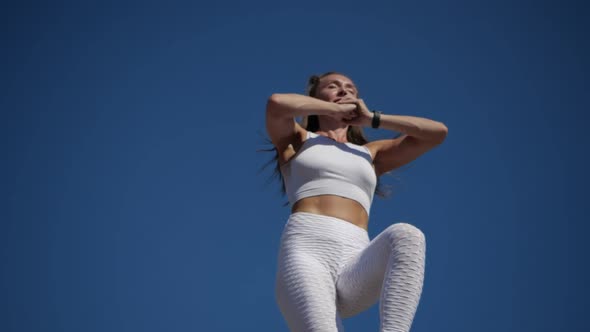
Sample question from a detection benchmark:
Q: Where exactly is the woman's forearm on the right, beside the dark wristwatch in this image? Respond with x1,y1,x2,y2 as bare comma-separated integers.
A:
379,114,448,142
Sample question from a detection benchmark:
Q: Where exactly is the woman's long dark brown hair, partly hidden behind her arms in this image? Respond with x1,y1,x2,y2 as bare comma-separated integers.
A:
262,71,389,200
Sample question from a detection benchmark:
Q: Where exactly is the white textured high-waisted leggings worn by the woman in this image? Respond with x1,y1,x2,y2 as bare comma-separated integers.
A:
275,212,426,332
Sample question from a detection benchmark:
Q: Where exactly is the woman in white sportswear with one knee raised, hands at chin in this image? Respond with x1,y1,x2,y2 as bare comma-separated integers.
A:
266,72,447,332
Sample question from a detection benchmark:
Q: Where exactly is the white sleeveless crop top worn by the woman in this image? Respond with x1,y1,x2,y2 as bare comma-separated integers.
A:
281,131,377,215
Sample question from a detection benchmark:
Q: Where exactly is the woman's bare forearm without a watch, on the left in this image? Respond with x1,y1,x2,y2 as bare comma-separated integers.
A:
266,93,340,118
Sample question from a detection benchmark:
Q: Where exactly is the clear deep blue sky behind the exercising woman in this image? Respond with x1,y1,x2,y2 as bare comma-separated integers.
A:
0,0,590,332
